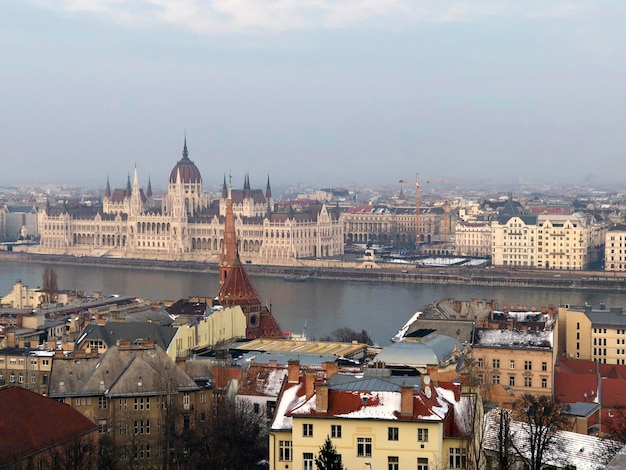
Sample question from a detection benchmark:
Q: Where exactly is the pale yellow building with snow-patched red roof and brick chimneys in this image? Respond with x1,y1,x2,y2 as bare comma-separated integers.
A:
270,363,473,470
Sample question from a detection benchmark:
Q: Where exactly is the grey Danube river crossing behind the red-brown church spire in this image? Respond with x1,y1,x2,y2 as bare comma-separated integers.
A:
0,260,626,345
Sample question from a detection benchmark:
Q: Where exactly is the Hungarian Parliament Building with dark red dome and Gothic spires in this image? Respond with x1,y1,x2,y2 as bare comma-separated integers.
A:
33,140,344,265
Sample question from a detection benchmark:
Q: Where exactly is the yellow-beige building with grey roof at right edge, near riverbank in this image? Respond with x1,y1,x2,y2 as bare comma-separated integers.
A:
556,305,626,364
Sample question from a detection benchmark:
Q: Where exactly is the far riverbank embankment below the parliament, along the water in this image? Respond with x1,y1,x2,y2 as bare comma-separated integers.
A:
0,252,626,292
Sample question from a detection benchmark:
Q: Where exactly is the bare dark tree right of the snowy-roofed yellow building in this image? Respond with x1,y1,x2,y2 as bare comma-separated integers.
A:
511,393,567,470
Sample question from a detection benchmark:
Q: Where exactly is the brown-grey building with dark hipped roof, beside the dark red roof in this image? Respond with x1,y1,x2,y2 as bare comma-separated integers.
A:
49,341,212,468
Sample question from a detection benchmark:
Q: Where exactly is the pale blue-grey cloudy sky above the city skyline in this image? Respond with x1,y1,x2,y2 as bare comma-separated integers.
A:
0,0,626,190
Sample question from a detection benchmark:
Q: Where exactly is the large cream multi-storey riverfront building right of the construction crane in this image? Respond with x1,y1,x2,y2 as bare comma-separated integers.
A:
491,212,606,270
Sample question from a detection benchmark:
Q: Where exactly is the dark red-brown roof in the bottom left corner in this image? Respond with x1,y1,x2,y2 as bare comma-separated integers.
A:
0,387,97,463
